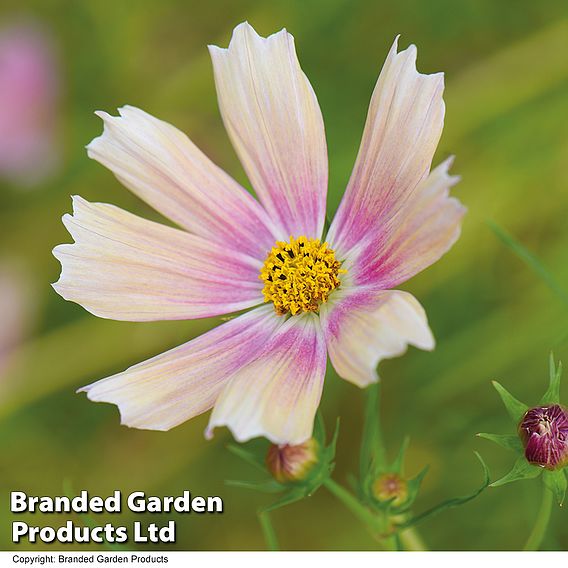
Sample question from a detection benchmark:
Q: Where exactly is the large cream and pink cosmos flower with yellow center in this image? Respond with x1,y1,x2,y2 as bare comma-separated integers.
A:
54,23,464,445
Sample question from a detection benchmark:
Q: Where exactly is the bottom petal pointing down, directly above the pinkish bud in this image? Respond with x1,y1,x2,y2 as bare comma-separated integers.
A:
207,313,326,444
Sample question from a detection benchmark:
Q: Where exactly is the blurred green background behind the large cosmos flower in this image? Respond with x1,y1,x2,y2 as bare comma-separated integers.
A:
0,0,568,550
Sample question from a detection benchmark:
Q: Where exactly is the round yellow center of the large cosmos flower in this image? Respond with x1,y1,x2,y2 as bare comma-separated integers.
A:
259,237,347,315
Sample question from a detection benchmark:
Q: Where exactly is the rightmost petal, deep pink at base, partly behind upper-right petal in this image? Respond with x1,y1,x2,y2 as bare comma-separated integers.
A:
345,158,466,289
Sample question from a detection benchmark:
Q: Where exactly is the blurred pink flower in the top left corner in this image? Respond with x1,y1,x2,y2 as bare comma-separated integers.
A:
0,23,59,185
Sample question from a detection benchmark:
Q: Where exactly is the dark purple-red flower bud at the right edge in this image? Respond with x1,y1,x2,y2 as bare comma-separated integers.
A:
519,404,568,470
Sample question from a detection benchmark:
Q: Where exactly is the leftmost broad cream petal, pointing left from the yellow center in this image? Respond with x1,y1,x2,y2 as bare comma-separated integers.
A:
53,197,263,321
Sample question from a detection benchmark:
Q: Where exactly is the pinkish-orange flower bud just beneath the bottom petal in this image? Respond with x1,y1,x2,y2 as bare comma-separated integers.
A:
266,438,318,483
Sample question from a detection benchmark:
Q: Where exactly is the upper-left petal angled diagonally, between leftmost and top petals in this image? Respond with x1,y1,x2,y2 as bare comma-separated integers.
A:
87,106,274,259
